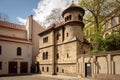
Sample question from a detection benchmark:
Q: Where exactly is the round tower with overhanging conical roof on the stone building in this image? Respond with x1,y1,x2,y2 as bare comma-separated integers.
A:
62,2,85,42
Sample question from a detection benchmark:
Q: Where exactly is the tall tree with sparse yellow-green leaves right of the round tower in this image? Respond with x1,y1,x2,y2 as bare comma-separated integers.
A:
80,0,120,51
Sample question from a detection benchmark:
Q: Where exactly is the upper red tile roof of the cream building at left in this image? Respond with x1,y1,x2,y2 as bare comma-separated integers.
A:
0,21,26,30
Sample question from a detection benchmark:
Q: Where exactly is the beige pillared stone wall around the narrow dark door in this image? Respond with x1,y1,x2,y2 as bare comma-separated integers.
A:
78,51,120,79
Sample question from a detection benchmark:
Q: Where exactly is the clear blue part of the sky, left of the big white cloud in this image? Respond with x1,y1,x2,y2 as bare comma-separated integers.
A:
0,0,40,23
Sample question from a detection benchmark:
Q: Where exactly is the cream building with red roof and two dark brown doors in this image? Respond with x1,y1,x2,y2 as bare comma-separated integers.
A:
0,16,44,75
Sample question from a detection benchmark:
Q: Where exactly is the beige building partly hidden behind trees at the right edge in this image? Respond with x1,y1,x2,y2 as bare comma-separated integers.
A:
103,10,120,38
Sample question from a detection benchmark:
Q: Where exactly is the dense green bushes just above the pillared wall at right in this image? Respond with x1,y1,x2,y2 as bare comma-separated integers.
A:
92,33,120,52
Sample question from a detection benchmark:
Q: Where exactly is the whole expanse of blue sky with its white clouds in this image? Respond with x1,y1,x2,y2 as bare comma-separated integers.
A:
0,0,77,24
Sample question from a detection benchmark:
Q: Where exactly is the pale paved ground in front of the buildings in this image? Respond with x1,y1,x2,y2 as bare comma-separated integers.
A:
0,74,96,80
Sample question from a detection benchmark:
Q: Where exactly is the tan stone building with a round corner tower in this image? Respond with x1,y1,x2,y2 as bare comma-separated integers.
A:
36,3,90,75
